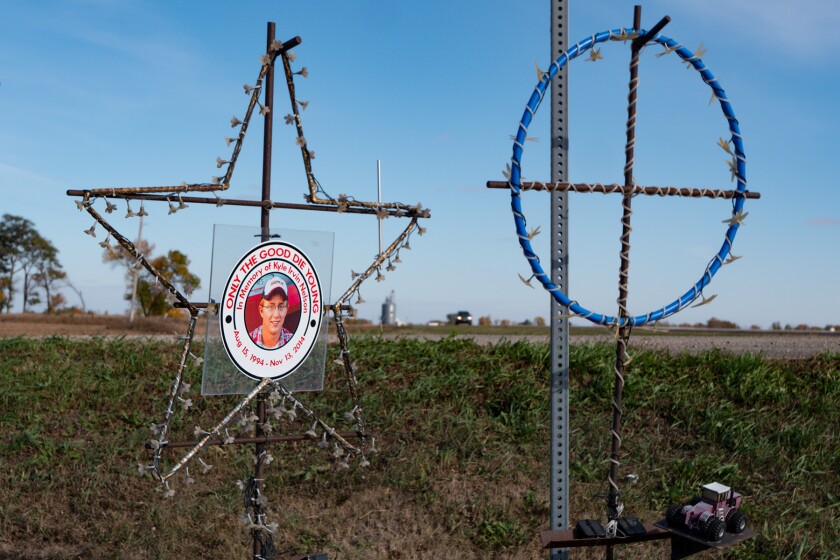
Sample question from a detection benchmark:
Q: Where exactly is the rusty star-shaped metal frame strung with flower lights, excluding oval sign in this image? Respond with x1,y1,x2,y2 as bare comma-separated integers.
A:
67,22,430,560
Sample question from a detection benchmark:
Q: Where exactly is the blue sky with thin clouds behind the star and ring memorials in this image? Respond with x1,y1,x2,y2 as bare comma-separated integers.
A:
0,0,840,327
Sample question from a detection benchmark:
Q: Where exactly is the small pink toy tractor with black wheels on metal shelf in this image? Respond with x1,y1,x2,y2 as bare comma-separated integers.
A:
665,482,747,542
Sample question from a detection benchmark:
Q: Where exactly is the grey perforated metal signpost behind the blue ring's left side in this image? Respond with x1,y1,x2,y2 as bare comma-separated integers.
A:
549,0,569,560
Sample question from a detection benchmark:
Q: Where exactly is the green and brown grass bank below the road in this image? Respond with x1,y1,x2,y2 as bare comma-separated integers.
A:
0,337,840,559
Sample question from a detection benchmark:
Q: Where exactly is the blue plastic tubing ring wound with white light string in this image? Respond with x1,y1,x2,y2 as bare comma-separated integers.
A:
509,28,747,326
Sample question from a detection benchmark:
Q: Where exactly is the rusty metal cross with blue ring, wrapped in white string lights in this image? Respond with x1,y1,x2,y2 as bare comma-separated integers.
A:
487,6,760,557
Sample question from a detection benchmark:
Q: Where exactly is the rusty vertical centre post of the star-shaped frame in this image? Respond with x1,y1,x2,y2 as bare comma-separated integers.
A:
251,21,275,559
